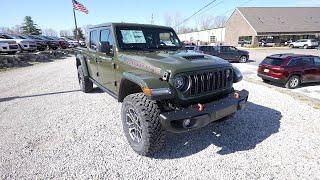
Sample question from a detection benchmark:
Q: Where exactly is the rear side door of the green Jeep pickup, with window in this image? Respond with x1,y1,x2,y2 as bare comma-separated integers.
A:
84,30,99,81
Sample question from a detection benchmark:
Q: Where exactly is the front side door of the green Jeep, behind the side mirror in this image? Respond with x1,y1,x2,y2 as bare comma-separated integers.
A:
97,27,116,92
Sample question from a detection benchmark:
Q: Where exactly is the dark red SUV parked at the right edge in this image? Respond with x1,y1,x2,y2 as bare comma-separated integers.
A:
258,54,320,89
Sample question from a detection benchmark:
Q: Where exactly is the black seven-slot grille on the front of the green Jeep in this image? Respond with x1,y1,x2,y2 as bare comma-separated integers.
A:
187,69,232,96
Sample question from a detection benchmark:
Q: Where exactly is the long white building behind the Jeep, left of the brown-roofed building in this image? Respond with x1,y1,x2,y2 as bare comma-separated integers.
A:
178,28,225,45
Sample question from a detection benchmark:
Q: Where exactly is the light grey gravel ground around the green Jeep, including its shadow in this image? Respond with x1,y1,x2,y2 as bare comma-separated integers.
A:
0,58,320,179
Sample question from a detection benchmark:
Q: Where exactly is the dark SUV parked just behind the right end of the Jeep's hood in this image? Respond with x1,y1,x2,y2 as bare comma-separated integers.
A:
196,46,249,63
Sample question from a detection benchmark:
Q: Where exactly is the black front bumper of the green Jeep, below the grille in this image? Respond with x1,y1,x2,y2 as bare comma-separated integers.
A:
160,90,249,133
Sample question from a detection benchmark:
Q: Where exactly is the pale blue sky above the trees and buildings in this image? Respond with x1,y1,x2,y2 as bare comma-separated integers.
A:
0,0,320,31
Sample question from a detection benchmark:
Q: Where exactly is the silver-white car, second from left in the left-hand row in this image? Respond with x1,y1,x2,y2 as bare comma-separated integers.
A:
0,34,37,52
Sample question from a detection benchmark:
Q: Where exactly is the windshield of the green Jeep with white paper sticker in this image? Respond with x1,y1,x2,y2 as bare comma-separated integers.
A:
116,27,181,50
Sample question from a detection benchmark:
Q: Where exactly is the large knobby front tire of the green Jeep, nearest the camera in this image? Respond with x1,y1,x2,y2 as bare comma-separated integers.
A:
121,93,165,156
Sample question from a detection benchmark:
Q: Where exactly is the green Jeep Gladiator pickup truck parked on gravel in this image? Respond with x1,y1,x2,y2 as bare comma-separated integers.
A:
76,23,248,156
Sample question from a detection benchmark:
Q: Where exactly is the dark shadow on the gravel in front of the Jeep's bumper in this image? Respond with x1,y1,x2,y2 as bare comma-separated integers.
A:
153,102,282,159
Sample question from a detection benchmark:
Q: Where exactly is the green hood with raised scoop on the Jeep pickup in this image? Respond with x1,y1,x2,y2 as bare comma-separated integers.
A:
120,51,231,75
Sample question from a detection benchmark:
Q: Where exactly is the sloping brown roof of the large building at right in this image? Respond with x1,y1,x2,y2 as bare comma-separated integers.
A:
237,7,320,34
